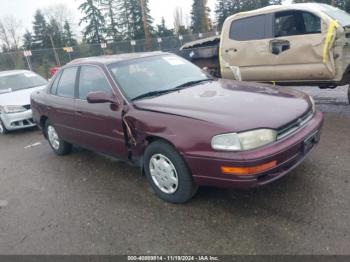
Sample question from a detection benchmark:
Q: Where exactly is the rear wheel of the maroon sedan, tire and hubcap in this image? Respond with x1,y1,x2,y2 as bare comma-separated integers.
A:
45,120,72,156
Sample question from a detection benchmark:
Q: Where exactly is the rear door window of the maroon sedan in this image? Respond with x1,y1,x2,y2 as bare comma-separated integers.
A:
57,67,77,98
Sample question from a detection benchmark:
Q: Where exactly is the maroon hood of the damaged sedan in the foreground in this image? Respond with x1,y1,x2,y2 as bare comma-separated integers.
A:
134,80,312,132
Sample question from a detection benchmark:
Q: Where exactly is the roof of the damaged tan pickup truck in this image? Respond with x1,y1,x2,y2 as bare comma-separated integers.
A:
230,3,329,19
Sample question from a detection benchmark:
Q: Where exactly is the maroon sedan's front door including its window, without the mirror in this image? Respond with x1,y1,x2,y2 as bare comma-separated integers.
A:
74,65,127,158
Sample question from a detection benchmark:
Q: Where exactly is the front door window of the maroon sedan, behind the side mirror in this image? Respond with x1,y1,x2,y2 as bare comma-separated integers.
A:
79,66,113,100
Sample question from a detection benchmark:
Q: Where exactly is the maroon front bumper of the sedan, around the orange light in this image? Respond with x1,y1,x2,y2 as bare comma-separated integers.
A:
184,112,323,188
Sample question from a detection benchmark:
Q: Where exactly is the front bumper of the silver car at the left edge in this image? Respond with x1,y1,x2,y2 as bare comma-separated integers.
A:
0,110,36,131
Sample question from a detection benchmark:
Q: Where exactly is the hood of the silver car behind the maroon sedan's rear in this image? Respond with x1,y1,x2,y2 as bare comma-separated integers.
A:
0,85,46,106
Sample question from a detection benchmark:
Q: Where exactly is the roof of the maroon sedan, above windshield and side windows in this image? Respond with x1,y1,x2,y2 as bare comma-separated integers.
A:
67,51,169,65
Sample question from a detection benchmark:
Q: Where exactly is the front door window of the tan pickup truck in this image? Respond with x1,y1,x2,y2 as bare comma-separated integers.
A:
275,11,321,37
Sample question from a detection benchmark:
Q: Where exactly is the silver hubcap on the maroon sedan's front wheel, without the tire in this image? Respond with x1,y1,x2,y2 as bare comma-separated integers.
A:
149,154,179,195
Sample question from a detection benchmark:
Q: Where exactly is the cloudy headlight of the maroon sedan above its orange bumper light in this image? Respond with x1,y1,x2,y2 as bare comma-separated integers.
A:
211,129,277,151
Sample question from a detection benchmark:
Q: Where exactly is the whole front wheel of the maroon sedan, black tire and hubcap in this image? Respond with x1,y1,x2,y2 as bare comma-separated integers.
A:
144,141,198,204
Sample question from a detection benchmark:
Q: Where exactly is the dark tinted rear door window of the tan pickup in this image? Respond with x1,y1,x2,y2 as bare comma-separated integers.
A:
230,15,272,41
